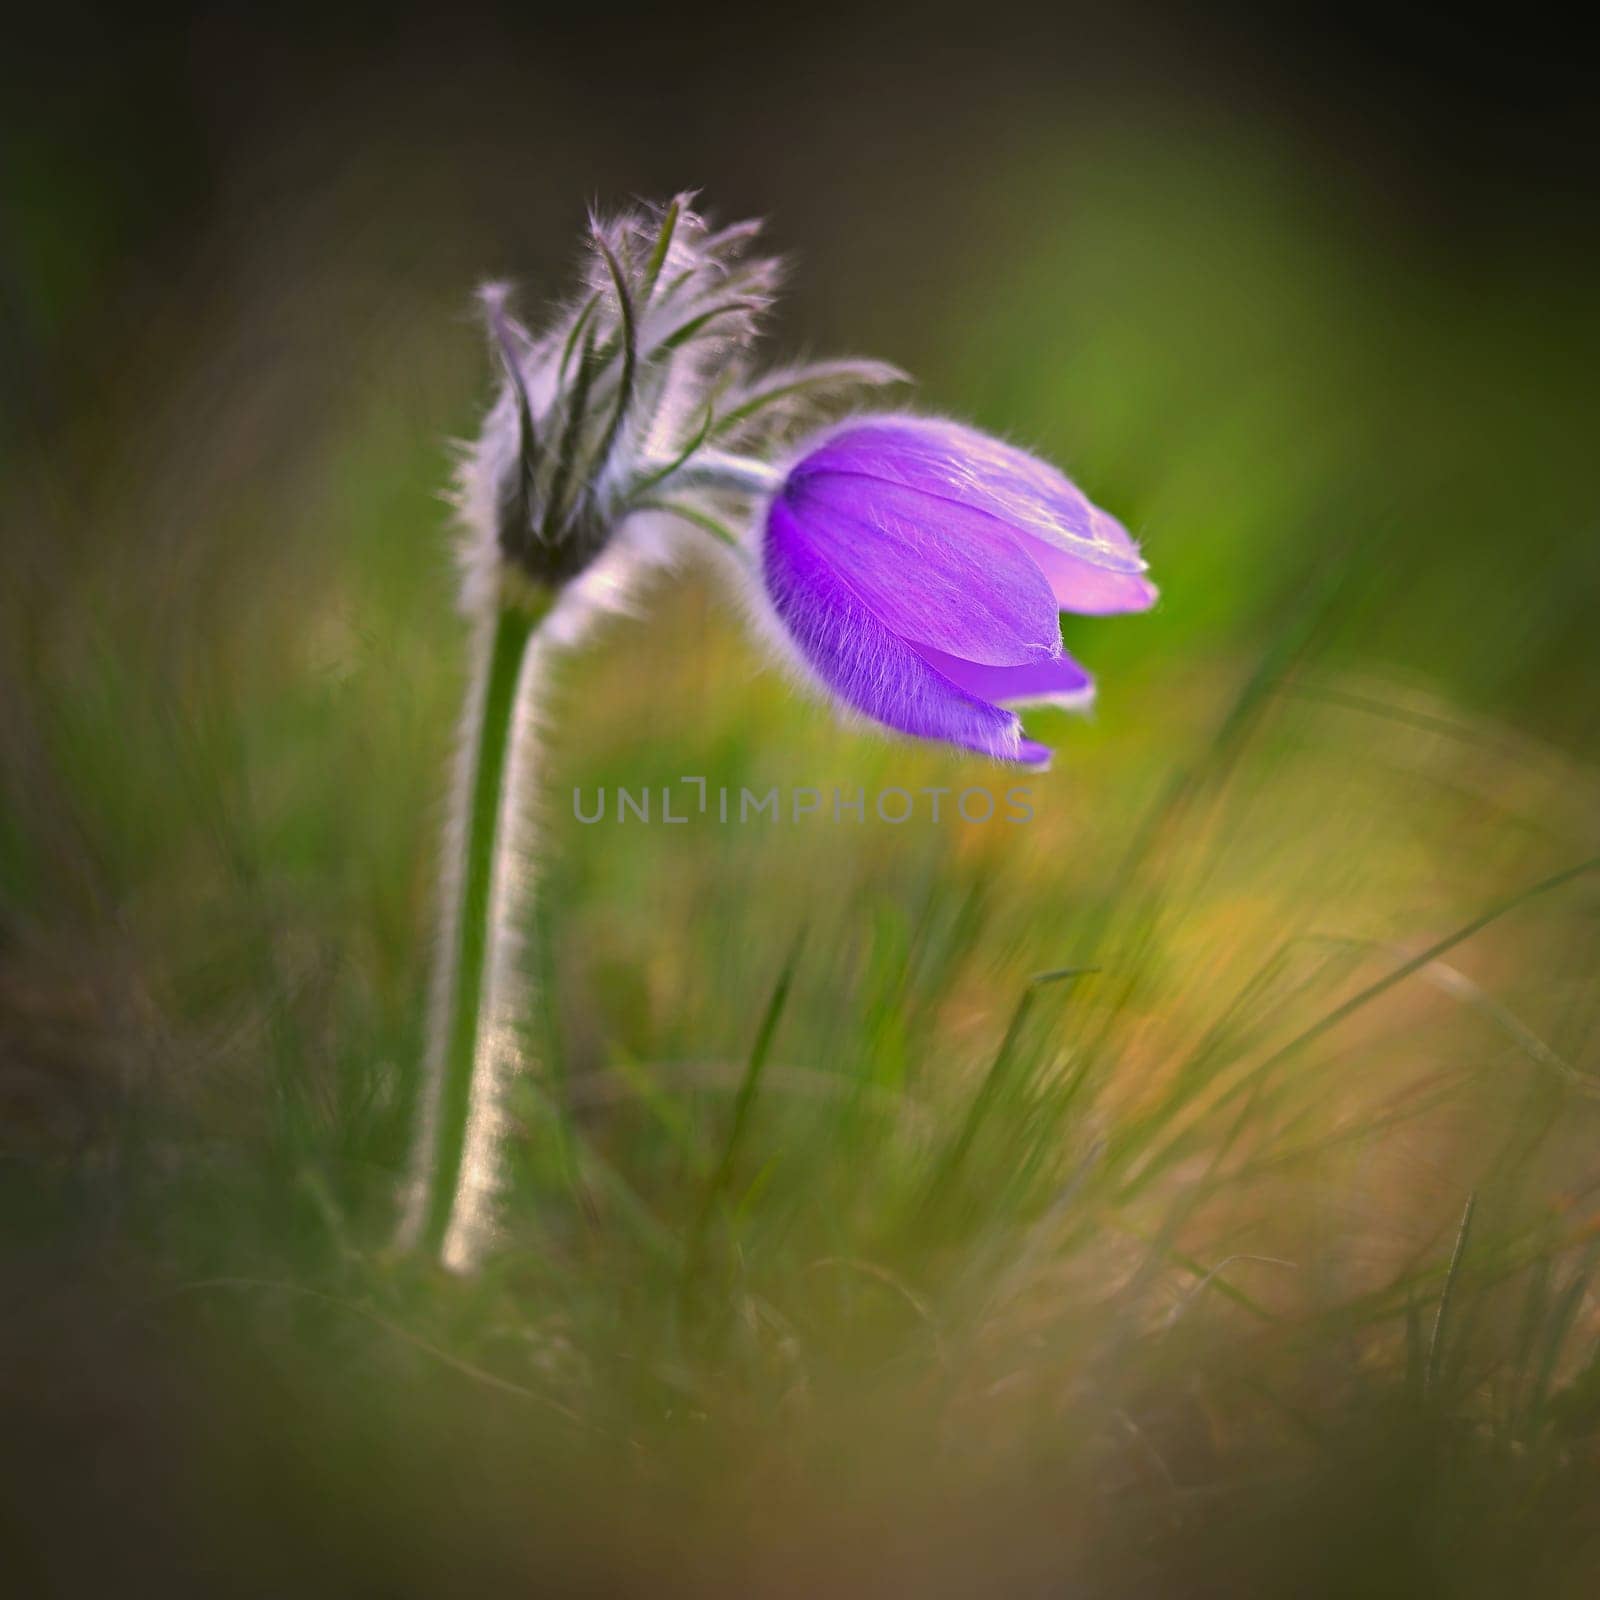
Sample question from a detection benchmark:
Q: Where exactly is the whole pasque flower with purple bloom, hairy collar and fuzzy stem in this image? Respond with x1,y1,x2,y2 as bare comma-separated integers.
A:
400,195,1155,1269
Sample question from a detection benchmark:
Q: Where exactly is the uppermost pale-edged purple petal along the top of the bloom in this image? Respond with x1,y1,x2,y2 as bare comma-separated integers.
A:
790,418,1146,573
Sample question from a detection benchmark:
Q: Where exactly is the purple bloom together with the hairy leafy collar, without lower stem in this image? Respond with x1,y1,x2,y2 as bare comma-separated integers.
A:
458,195,1155,766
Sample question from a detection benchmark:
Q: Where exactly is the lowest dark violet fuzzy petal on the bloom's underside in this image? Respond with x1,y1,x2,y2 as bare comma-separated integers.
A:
763,496,1050,766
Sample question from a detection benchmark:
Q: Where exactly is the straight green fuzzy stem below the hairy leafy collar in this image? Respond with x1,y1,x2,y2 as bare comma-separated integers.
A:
400,603,547,1270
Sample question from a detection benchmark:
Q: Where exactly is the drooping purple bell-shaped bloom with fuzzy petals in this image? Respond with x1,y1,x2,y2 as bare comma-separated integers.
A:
762,416,1155,766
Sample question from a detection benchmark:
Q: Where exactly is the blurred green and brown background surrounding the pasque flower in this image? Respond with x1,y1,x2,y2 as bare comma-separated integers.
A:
0,3,1600,1594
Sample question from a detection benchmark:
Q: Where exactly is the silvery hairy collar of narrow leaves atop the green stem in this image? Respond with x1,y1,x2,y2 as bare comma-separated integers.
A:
456,194,901,602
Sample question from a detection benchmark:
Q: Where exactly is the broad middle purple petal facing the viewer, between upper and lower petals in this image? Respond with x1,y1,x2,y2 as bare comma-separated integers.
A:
782,474,1061,666
